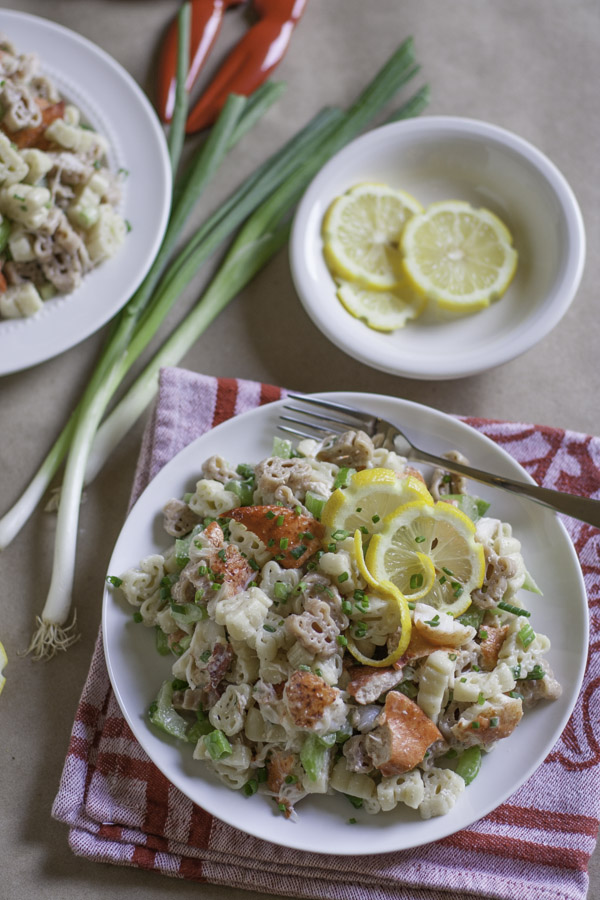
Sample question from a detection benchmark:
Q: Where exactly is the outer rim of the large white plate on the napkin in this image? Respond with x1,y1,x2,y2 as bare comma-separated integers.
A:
102,391,589,856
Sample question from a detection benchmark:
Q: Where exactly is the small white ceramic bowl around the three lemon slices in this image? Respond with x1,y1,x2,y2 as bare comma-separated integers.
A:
290,116,585,380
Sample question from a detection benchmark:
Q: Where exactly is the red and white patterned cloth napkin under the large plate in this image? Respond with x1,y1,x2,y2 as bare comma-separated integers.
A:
53,369,600,900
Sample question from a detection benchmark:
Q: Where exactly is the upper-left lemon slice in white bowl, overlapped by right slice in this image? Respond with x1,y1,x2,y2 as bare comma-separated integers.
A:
323,184,423,291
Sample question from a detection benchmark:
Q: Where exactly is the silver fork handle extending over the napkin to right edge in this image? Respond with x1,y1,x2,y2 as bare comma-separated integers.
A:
408,449,600,528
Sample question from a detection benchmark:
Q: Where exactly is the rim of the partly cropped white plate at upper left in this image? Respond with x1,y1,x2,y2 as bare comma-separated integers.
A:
0,9,172,377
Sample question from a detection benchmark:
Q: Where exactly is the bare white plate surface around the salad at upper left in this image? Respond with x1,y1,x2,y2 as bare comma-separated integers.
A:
0,9,171,375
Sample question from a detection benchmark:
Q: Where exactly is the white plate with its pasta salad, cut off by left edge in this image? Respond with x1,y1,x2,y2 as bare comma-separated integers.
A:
0,10,171,375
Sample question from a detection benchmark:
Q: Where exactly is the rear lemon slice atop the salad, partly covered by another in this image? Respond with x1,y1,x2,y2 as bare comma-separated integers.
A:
321,468,433,542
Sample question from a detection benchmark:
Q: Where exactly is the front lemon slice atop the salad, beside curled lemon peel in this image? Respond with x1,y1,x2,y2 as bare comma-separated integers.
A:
366,500,485,616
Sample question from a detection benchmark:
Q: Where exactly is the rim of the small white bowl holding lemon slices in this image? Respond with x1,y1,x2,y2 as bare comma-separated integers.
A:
290,116,586,378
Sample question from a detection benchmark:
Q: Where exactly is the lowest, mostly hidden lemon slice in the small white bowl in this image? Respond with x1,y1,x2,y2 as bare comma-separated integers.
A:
337,279,427,332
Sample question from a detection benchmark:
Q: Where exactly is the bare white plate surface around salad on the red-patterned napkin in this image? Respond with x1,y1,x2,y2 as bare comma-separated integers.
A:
103,393,588,855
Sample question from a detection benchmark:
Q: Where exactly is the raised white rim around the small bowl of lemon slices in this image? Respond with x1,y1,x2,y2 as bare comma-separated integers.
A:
288,115,586,381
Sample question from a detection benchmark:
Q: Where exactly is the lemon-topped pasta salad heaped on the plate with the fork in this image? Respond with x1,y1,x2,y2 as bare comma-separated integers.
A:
108,431,561,819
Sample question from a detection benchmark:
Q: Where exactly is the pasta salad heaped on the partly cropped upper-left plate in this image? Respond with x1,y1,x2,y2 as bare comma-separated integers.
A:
0,35,128,319
